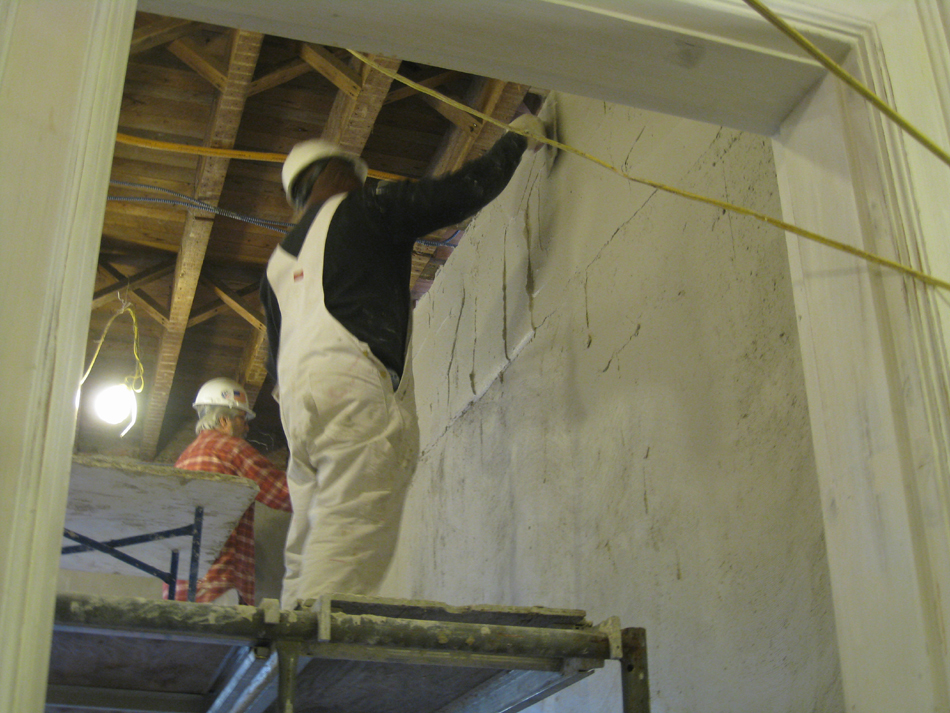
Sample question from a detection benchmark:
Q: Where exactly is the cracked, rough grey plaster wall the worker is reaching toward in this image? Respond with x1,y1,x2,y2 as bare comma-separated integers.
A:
382,95,844,713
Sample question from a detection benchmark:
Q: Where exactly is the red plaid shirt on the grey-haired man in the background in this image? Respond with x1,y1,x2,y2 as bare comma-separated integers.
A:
166,429,290,605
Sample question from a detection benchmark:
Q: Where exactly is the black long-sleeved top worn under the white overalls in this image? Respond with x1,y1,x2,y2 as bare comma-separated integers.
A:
260,133,527,381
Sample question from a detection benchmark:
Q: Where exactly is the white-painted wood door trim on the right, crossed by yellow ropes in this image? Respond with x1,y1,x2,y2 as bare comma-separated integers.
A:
776,3,950,710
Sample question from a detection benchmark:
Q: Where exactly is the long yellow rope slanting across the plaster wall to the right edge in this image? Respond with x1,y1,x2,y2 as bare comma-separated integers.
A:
349,50,950,291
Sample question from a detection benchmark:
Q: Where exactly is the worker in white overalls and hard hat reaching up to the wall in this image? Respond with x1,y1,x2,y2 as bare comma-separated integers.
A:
261,114,544,608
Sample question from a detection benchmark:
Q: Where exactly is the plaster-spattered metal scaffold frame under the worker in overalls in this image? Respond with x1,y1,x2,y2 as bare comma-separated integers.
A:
48,594,650,713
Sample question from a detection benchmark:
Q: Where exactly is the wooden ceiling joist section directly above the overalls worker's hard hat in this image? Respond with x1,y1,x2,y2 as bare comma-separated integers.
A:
323,57,400,156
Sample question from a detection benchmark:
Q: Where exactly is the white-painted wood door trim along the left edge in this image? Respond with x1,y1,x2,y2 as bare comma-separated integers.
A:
0,0,136,711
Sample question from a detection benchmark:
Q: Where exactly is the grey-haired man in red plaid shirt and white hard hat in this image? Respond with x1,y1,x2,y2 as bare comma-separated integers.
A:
175,378,291,605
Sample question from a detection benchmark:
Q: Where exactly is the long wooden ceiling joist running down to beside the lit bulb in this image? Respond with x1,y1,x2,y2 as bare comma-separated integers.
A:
141,30,263,460
